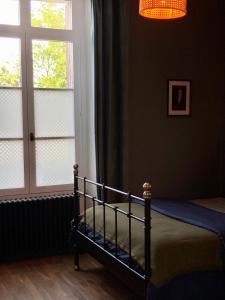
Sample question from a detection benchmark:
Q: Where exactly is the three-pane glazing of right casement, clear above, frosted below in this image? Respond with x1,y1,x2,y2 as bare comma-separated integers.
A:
32,39,75,192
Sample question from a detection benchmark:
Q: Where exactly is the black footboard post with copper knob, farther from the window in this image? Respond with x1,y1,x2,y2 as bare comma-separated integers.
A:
143,182,151,299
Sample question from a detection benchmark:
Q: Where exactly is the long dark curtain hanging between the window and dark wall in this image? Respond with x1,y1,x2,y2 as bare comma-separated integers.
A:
93,0,128,188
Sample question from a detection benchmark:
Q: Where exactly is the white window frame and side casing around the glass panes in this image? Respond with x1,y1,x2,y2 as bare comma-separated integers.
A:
0,0,95,199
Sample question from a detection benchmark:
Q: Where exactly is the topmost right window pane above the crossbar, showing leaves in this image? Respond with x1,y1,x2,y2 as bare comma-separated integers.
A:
31,0,72,29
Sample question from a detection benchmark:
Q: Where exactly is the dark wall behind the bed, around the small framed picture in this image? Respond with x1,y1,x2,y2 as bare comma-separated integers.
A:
126,0,225,198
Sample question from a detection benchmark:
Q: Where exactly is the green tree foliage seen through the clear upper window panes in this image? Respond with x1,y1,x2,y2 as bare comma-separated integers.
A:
0,2,69,88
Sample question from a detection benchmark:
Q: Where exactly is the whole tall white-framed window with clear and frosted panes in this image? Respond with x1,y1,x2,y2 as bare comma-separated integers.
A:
0,0,93,196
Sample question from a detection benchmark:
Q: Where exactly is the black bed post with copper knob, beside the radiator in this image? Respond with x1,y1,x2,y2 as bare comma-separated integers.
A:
73,164,80,271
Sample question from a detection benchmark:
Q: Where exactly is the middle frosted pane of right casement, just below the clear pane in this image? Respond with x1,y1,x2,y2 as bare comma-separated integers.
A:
34,90,74,137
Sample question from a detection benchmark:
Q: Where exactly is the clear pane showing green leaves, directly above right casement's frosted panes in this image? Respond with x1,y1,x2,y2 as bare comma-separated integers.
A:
32,40,73,88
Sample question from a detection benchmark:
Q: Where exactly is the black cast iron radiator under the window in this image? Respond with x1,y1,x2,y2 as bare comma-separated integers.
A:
0,194,74,261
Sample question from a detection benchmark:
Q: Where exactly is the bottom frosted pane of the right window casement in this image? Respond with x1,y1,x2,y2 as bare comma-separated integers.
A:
36,139,75,186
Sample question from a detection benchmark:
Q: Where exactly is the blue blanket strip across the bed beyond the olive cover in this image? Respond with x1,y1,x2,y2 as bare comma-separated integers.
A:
151,199,225,248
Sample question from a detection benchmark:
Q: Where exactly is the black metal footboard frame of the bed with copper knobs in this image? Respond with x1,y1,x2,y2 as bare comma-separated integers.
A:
73,164,151,299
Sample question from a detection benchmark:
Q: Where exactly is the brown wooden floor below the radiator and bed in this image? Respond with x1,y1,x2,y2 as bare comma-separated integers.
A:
0,254,141,300
